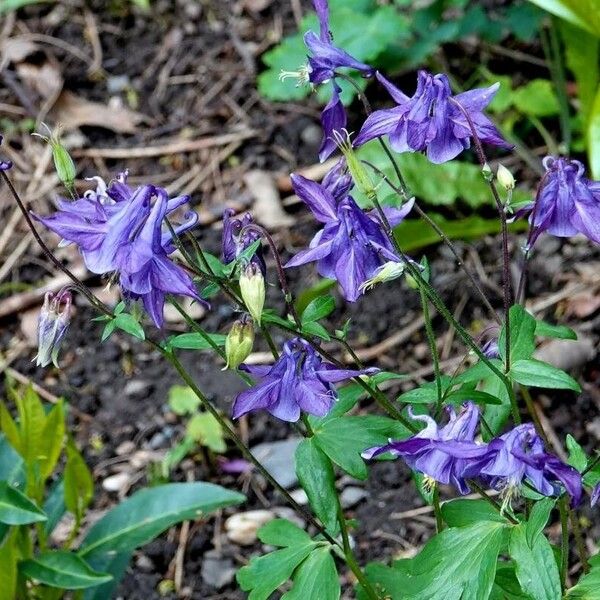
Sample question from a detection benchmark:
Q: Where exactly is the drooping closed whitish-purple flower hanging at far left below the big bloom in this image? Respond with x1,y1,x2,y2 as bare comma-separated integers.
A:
35,290,71,367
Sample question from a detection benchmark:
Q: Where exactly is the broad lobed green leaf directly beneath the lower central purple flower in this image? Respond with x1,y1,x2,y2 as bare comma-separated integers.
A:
314,415,410,479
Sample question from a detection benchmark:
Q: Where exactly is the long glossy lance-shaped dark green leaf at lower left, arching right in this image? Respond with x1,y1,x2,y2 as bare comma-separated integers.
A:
79,482,245,557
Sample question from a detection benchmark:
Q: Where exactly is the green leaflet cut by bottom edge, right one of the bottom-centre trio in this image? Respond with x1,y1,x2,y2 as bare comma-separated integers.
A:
281,547,341,600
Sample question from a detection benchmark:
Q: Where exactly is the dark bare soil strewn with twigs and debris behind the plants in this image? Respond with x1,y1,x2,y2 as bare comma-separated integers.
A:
0,0,600,600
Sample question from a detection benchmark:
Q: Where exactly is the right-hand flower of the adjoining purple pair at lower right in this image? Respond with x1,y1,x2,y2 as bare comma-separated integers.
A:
468,423,582,506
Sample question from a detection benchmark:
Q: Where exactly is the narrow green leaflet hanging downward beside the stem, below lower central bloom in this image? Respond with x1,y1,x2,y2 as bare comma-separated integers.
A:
295,437,338,533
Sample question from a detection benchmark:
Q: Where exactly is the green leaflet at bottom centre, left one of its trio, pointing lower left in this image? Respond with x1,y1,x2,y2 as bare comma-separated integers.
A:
236,541,318,600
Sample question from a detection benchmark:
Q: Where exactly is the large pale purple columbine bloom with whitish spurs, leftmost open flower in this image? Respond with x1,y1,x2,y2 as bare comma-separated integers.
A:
34,173,203,327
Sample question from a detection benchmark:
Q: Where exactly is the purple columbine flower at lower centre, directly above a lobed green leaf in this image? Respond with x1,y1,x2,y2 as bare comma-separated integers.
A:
233,338,378,422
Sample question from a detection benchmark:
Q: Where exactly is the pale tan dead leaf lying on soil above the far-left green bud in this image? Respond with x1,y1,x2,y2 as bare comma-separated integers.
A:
51,91,144,133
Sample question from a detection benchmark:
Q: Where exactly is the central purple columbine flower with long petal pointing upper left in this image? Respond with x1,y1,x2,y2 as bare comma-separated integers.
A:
285,174,414,302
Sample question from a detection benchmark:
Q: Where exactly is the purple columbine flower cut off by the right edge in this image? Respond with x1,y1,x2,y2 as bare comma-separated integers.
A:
529,156,600,246
